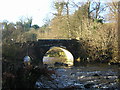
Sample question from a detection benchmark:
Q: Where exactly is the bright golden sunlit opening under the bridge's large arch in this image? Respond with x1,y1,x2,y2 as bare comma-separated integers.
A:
42,46,74,66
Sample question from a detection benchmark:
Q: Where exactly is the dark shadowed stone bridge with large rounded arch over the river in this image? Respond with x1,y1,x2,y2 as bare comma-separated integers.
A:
16,39,86,64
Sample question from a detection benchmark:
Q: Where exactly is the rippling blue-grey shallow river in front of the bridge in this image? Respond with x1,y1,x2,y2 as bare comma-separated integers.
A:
35,64,120,90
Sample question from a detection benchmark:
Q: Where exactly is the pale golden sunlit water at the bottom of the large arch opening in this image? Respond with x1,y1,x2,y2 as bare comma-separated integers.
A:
43,57,73,66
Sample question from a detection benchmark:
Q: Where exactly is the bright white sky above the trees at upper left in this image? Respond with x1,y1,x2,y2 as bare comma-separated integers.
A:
0,0,52,26
